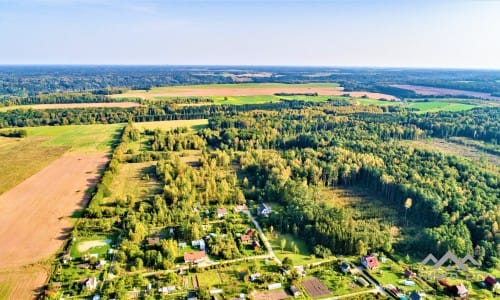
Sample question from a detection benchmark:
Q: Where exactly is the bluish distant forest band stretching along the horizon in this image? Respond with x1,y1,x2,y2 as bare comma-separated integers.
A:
0,66,500,99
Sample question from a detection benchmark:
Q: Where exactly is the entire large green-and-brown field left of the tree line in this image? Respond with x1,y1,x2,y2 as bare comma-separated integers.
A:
0,125,123,299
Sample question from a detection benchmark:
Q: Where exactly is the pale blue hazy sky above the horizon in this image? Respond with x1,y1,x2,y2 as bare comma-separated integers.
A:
0,0,500,69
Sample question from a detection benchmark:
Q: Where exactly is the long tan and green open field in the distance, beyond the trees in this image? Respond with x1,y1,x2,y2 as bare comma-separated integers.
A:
110,83,396,100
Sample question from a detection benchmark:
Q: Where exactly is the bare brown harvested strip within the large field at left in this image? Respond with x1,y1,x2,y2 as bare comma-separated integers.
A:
0,154,108,269
